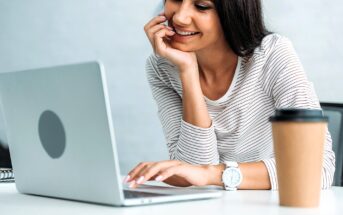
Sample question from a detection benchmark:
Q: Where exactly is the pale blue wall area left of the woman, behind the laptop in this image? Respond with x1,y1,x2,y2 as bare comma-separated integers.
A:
0,0,168,172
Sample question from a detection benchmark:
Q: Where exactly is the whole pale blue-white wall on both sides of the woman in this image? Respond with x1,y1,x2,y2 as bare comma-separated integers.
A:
0,0,343,174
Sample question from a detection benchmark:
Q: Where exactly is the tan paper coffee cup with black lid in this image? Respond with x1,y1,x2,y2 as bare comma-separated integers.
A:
269,109,328,207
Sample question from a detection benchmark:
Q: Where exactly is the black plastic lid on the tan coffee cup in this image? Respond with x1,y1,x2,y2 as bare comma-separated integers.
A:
269,109,329,122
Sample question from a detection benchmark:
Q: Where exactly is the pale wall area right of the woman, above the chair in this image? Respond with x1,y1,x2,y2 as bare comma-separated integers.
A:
263,0,343,103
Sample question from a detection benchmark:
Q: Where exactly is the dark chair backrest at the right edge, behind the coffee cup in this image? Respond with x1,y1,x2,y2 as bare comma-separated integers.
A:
321,103,343,186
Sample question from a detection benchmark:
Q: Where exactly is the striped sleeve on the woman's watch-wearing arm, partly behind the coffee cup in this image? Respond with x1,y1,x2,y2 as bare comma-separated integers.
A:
263,38,335,190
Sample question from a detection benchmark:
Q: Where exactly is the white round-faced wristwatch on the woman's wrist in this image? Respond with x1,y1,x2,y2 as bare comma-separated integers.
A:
222,161,243,191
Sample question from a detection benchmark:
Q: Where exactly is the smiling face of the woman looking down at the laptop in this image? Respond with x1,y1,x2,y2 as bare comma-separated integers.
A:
164,0,226,52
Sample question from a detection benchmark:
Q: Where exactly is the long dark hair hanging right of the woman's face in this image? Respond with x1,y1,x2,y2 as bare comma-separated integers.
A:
214,0,271,57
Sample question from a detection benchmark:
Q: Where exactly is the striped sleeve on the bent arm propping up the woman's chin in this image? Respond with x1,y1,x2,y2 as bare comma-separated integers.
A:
146,55,219,164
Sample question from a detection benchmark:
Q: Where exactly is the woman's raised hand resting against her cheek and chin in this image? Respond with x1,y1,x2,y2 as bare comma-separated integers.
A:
144,14,197,71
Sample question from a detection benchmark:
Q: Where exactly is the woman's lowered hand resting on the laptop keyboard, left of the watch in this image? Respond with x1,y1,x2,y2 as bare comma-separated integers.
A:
124,160,211,188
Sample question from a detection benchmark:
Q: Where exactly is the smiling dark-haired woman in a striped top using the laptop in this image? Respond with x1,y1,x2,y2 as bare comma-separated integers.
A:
125,0,335,190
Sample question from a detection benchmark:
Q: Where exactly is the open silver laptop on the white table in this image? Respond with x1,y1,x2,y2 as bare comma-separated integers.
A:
0,62,222,206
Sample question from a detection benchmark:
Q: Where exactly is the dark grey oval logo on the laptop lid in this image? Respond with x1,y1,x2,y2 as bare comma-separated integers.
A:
38,110,66,159
